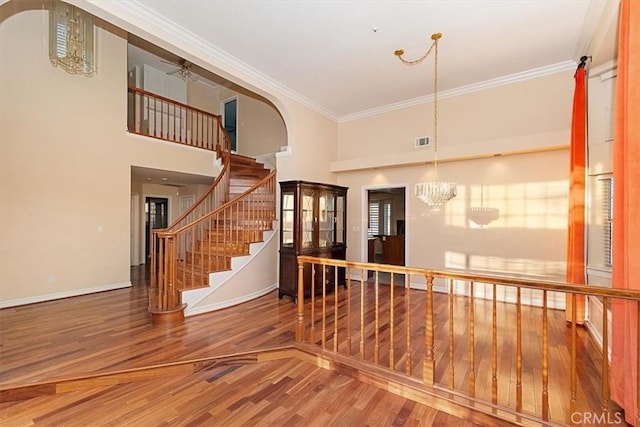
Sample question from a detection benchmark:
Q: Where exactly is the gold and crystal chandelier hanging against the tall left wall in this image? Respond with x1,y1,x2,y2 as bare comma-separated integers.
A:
49,0,95,77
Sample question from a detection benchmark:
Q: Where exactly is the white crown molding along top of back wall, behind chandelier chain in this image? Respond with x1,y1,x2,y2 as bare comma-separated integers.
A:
338,60,577,123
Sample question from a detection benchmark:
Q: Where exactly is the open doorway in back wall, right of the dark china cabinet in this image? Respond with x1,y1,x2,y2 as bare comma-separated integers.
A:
367,187,406,265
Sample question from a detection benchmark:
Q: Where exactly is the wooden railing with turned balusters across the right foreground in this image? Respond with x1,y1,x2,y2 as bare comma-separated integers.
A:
296,256,640,425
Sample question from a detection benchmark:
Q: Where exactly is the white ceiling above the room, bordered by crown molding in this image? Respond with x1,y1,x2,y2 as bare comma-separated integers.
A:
87,0,617,120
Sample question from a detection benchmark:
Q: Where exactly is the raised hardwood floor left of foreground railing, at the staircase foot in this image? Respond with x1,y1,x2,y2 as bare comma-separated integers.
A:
0,267,296,385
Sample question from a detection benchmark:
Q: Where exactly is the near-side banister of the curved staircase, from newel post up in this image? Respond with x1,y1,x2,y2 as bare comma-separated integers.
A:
149,170,276,313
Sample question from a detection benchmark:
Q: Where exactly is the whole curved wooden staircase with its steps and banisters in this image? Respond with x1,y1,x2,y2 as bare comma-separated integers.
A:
149,150,276,324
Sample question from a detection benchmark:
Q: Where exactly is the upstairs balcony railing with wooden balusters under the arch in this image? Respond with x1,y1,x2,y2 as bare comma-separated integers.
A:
127,86,224,155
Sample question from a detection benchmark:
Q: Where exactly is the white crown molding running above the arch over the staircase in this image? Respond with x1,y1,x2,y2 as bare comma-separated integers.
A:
79,0,338,122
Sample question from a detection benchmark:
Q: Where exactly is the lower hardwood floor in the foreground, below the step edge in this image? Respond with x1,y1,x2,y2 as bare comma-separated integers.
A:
0,358,482,426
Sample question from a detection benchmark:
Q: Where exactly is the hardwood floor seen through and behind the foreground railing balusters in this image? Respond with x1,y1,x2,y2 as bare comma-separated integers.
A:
298,281,620,425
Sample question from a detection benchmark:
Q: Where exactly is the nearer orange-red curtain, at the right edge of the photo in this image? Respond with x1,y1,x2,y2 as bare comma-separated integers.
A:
611,0,640,425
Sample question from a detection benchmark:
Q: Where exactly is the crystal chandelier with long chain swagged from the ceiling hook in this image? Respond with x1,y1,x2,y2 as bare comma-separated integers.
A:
394,33,457,210
